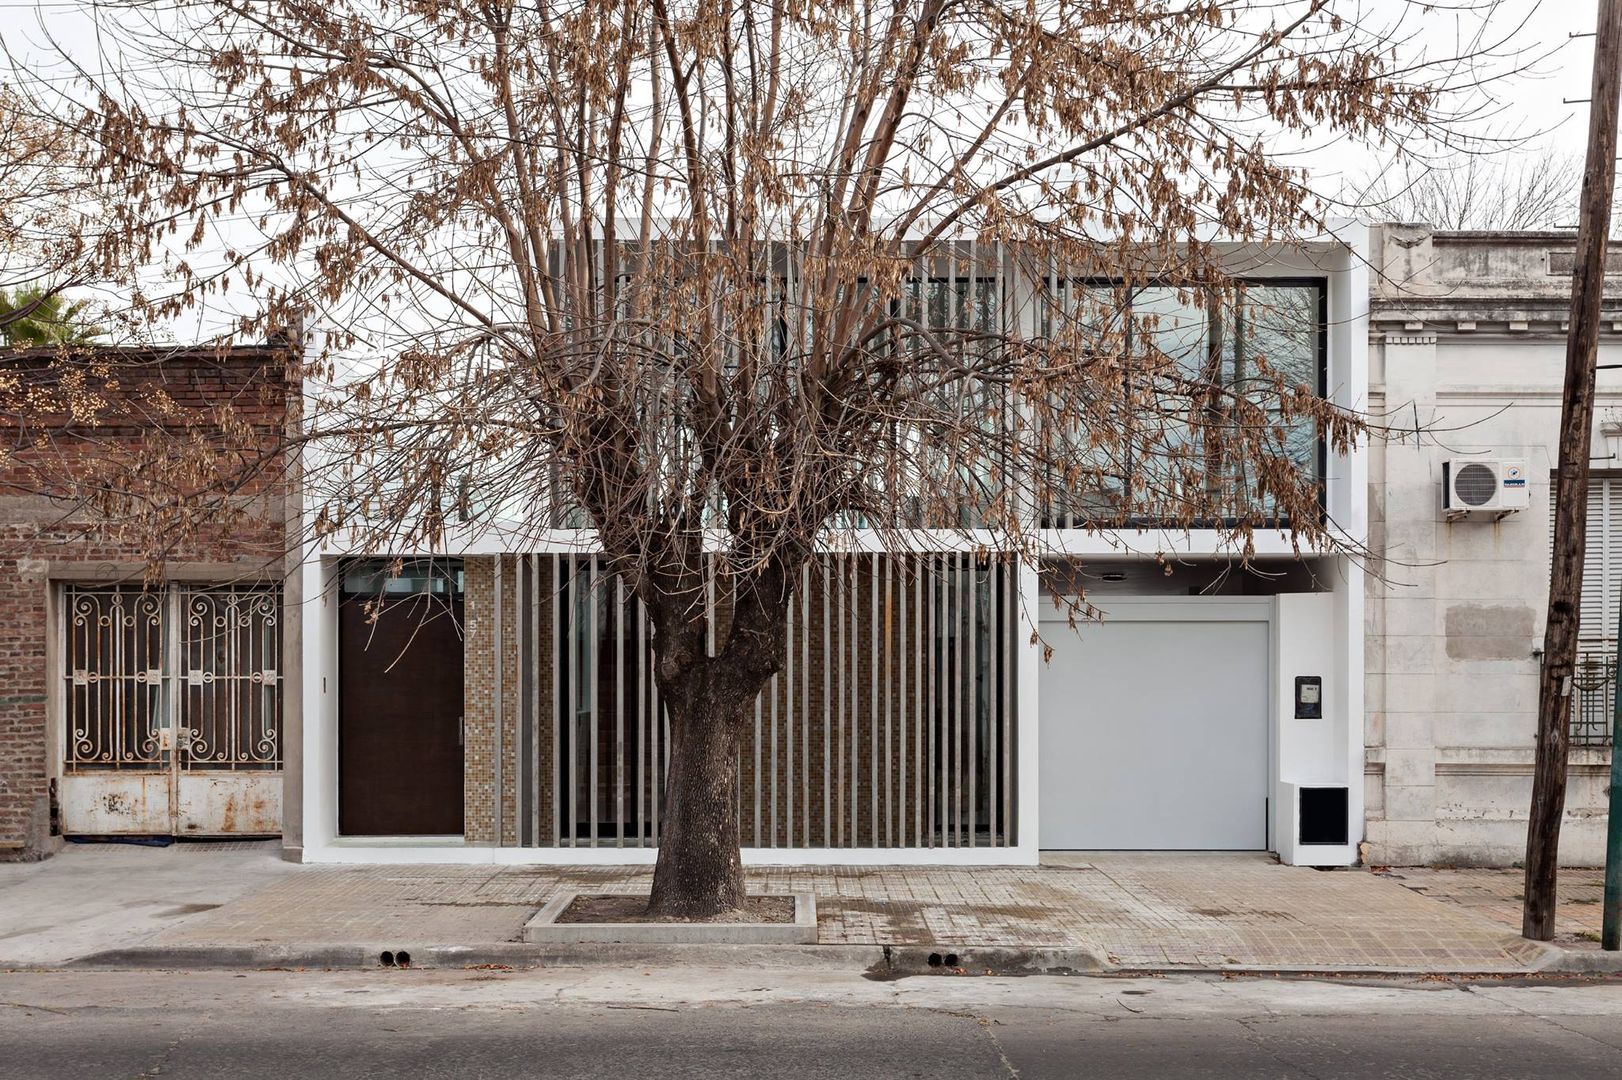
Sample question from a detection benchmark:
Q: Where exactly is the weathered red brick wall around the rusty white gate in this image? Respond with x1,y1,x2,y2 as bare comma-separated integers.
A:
0,347,287,858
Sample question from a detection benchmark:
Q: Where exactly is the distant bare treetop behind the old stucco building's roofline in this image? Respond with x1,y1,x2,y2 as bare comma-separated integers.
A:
1346,149,1583,230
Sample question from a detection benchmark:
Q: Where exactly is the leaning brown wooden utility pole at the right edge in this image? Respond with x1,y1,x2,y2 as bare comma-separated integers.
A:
1521,0,1622,941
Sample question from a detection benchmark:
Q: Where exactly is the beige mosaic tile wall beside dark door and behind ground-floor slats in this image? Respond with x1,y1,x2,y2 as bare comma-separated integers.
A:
464,555,1015,846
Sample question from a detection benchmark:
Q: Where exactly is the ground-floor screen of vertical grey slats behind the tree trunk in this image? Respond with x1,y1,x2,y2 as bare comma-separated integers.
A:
514,551,1019,848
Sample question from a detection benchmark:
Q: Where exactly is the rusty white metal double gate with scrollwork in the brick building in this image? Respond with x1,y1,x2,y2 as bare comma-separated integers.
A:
60,584,282,835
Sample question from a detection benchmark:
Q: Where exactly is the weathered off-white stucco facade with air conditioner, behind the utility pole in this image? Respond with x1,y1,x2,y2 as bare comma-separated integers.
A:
1366,225,1622,864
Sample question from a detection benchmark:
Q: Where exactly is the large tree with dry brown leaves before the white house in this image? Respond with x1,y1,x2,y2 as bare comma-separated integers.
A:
12,0,1524,916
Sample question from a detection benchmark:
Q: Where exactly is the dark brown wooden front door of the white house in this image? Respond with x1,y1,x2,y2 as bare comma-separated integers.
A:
337,571,462,837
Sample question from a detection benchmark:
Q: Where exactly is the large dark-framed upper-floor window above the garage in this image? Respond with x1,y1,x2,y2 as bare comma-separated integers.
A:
1043,279,1325,527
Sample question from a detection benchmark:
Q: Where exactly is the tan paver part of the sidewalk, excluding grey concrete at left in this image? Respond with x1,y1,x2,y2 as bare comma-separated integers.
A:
154,855,1541,971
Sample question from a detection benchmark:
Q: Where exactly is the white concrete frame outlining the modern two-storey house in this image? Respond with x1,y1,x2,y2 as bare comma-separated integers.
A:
289,224,1369,866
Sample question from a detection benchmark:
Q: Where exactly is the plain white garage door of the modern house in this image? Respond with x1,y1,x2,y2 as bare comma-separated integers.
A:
1040,613,1268,850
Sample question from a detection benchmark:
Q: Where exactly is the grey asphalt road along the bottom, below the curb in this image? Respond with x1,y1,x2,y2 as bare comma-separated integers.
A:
0,971,1622,1080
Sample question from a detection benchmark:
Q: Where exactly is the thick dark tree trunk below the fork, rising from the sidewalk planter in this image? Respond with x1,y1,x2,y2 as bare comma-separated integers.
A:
647,689,754,919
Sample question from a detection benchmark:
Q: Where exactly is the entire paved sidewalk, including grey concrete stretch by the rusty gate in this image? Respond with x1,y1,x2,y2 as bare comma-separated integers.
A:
0,843,1570,973
